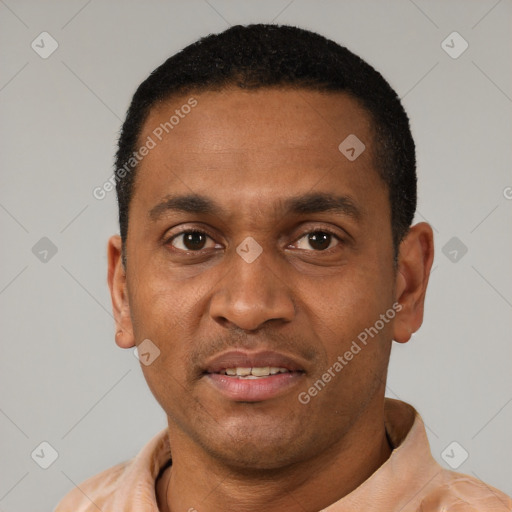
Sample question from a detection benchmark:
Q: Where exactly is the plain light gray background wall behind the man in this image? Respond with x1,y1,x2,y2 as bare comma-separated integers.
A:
0,0,512,512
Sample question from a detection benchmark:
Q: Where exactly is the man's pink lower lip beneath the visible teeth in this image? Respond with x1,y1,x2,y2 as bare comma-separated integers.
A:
206,372,304,402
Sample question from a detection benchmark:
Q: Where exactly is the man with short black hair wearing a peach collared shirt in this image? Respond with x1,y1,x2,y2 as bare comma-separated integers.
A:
56,25,512,512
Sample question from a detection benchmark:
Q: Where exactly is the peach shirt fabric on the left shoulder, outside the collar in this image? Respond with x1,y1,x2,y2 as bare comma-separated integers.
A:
54,461,131,512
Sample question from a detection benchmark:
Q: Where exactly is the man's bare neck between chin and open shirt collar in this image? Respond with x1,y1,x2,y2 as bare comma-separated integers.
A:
157,400,391,512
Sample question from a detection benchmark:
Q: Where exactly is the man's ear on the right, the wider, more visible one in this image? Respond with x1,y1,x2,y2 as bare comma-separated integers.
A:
393,222,434,343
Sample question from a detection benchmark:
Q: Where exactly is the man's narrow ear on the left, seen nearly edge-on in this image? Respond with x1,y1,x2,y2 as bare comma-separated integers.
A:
108,235,135,348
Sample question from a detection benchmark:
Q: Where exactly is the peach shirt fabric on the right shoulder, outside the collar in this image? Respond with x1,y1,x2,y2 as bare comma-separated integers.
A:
419,469,512,512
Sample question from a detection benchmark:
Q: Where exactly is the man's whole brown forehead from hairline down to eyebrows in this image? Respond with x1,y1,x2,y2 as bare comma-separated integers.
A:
134,89,382,222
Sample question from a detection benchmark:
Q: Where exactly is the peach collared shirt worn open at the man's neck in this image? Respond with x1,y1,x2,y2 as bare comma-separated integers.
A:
54,398,512,512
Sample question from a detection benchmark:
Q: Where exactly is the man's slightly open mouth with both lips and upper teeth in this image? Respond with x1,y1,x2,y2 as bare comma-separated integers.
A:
203,351,305,402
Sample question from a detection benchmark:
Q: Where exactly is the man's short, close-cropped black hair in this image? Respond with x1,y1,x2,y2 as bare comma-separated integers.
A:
115,24,417,261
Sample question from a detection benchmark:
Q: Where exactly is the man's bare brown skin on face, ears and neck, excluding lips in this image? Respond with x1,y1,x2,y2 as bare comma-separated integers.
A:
108,89,433,512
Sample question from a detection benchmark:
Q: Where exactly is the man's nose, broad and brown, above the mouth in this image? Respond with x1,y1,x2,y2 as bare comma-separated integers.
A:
210,243,295,331
